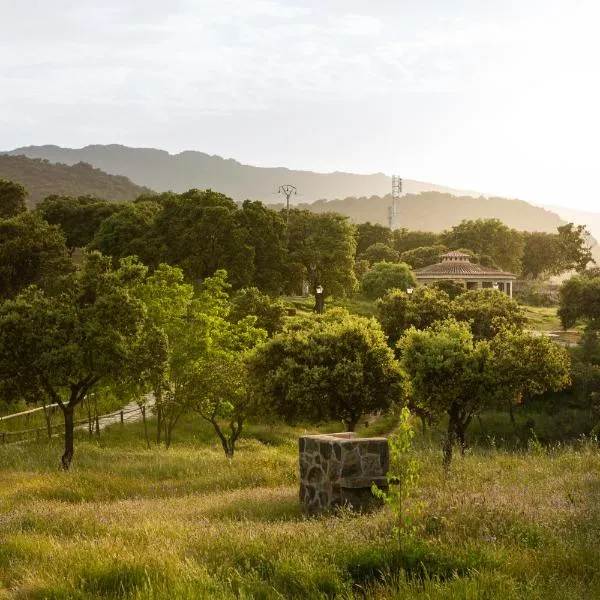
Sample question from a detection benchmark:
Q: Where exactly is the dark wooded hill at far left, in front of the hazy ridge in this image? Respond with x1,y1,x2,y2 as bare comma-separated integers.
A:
0,154,151,206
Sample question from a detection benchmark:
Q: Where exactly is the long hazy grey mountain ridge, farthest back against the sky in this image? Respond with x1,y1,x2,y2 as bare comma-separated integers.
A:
3,145,469,204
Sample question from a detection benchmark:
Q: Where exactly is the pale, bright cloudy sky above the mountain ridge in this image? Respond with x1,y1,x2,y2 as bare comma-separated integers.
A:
0,0,600,212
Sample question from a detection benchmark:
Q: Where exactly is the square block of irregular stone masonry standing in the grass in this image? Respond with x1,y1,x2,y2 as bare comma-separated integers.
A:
300,433,390,513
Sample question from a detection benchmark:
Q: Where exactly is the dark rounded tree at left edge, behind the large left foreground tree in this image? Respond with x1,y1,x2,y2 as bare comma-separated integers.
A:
0,212,73,298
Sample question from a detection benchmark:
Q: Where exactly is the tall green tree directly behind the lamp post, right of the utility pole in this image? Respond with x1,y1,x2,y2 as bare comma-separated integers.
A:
288,210,357,297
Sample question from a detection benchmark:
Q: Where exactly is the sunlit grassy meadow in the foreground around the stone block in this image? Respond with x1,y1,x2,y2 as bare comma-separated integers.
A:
0,412,600,600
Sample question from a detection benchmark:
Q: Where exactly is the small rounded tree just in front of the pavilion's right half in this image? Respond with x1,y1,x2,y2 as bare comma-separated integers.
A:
450,289,526,340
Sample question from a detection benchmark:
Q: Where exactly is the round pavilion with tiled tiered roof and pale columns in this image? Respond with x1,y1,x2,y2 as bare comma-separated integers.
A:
415,251,516,297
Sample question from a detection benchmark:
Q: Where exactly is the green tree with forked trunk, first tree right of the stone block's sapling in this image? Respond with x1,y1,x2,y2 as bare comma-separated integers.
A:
398,320,490,467
